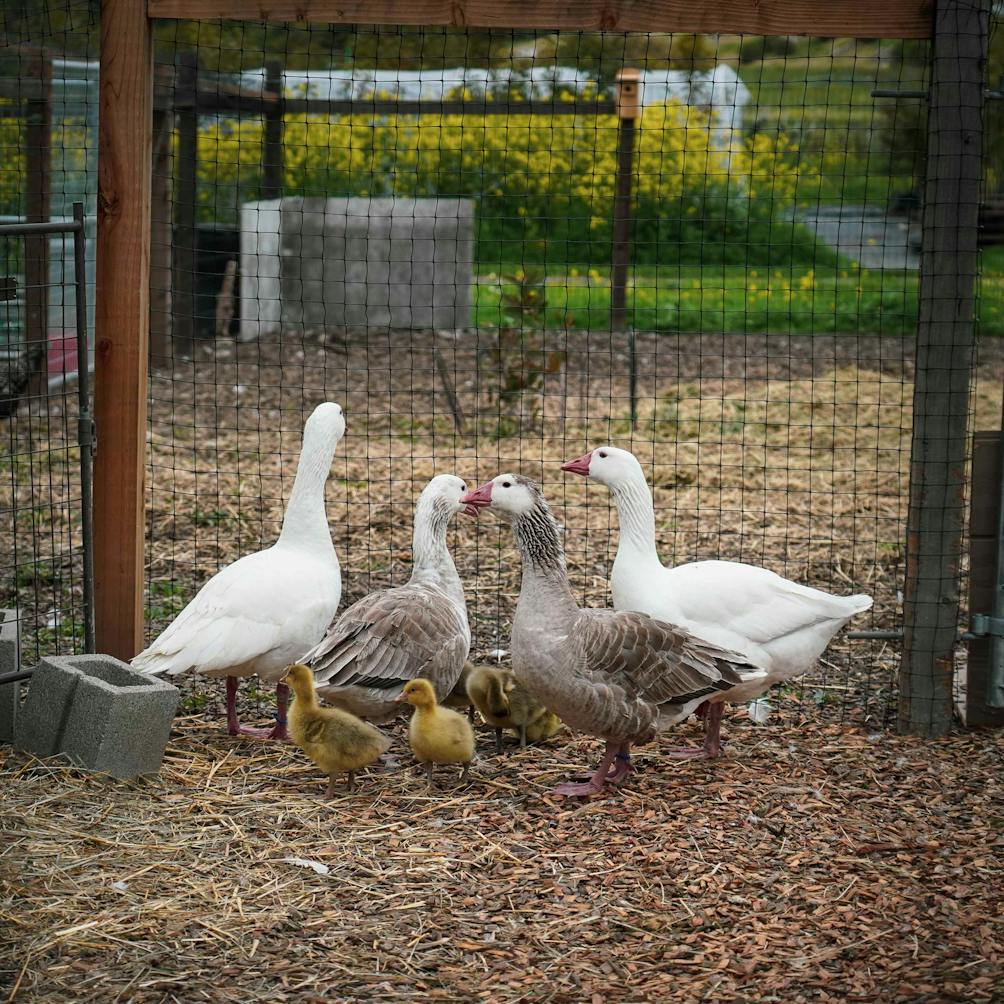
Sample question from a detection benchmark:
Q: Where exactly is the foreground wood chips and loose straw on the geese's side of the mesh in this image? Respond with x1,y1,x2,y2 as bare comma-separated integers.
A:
0,711,1004,1004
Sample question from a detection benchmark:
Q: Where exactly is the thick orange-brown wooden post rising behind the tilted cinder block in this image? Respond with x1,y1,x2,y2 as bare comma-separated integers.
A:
94,0,153,659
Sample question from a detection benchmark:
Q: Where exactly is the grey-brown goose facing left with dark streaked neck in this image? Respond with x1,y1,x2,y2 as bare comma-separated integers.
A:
462,474,762,796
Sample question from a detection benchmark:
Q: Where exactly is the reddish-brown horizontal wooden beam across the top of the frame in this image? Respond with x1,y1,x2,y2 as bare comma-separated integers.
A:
147,0,934,38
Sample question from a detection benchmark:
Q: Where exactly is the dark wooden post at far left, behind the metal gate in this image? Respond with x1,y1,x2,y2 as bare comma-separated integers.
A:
24,49,52,395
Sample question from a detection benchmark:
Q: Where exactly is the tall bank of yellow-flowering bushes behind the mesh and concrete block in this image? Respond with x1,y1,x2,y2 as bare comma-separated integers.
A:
199,101,816,265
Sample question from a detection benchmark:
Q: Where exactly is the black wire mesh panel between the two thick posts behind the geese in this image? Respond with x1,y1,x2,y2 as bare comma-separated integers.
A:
3,13,1001,726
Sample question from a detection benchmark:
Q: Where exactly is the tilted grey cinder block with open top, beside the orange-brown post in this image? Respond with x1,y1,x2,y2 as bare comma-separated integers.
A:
16,656,180,778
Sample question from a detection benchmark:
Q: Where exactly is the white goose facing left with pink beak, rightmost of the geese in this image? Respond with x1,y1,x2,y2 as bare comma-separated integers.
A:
561,446,871,757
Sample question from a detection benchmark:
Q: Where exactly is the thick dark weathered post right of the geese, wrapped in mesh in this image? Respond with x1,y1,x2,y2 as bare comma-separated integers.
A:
899,0,989,736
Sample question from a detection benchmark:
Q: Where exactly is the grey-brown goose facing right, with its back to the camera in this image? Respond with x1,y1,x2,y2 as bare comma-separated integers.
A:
301,474,477,722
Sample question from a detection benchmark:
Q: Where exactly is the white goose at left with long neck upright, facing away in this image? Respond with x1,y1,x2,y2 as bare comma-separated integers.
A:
133,404,345,739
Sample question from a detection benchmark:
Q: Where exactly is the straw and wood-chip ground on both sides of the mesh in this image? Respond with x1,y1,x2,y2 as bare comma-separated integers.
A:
0,332,1004,1004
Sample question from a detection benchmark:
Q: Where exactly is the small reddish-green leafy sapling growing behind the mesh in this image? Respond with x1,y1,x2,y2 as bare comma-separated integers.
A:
489,268,571,439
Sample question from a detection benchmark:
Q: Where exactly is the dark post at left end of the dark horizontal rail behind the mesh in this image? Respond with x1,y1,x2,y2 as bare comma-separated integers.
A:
171,49,199,355
